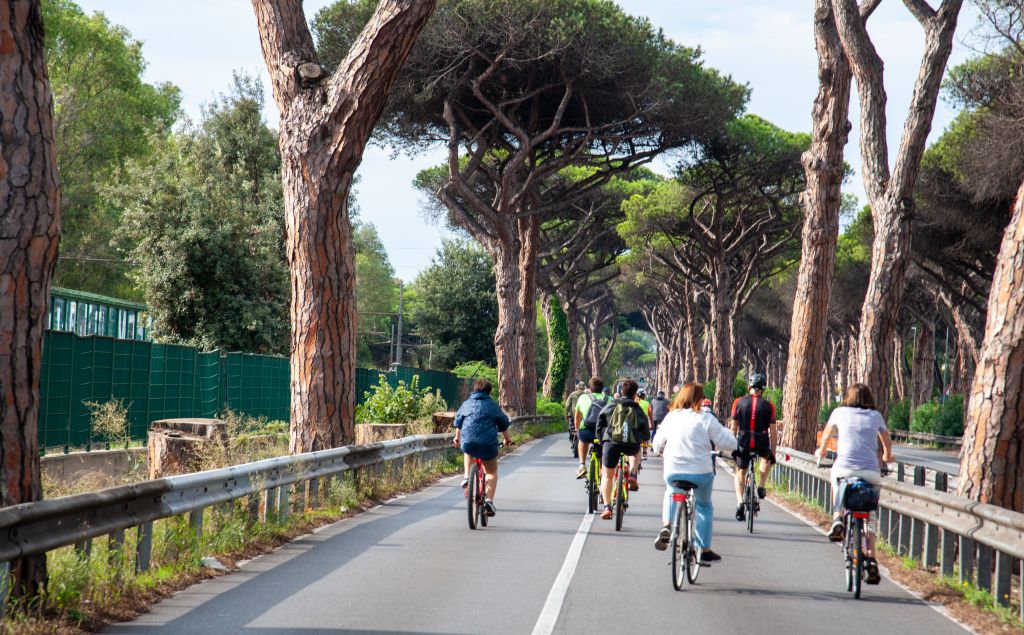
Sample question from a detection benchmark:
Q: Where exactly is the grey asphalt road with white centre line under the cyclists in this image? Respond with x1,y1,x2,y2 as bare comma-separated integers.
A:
105,436,965,635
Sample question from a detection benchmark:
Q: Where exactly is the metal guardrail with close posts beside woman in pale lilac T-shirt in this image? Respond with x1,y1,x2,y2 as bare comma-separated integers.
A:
772,448,1024,621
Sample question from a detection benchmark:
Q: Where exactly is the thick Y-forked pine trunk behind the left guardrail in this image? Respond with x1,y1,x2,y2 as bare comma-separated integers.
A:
253,0,434,453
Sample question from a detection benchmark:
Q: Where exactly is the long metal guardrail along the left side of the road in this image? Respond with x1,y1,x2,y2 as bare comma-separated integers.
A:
0,434,453,616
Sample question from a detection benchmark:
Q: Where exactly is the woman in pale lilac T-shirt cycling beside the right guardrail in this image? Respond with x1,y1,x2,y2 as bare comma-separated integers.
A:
814,384,893,584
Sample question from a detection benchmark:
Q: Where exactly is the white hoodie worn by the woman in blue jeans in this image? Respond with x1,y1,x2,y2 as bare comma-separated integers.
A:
652,409,736,474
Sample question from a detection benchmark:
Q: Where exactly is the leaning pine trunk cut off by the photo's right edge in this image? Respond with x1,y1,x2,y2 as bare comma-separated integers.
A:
959,184,1024,512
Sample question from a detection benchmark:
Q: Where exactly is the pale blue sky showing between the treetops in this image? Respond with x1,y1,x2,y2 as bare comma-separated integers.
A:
78,0,976,282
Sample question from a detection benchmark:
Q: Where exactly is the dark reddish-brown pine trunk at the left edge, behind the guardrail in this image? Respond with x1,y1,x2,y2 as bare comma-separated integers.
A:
0,0,60,597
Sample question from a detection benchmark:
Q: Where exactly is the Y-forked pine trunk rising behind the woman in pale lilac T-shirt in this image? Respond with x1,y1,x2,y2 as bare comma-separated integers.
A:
831,0,963,415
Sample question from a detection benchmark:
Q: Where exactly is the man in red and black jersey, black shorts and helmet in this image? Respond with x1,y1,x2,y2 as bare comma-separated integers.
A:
729,373,775,520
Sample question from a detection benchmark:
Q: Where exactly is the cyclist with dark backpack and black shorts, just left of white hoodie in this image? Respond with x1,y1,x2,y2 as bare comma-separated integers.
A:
597,379,650,520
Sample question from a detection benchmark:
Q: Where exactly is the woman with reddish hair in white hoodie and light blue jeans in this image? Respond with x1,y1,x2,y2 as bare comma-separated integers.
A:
651,383,736,562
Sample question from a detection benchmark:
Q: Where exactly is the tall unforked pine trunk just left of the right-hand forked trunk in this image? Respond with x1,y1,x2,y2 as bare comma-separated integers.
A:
782,0,852,452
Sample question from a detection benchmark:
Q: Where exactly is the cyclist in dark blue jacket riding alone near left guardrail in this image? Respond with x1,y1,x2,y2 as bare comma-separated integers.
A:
454,379,512,516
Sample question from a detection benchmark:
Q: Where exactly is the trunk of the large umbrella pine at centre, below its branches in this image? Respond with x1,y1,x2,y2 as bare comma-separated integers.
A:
489,216,540,416
